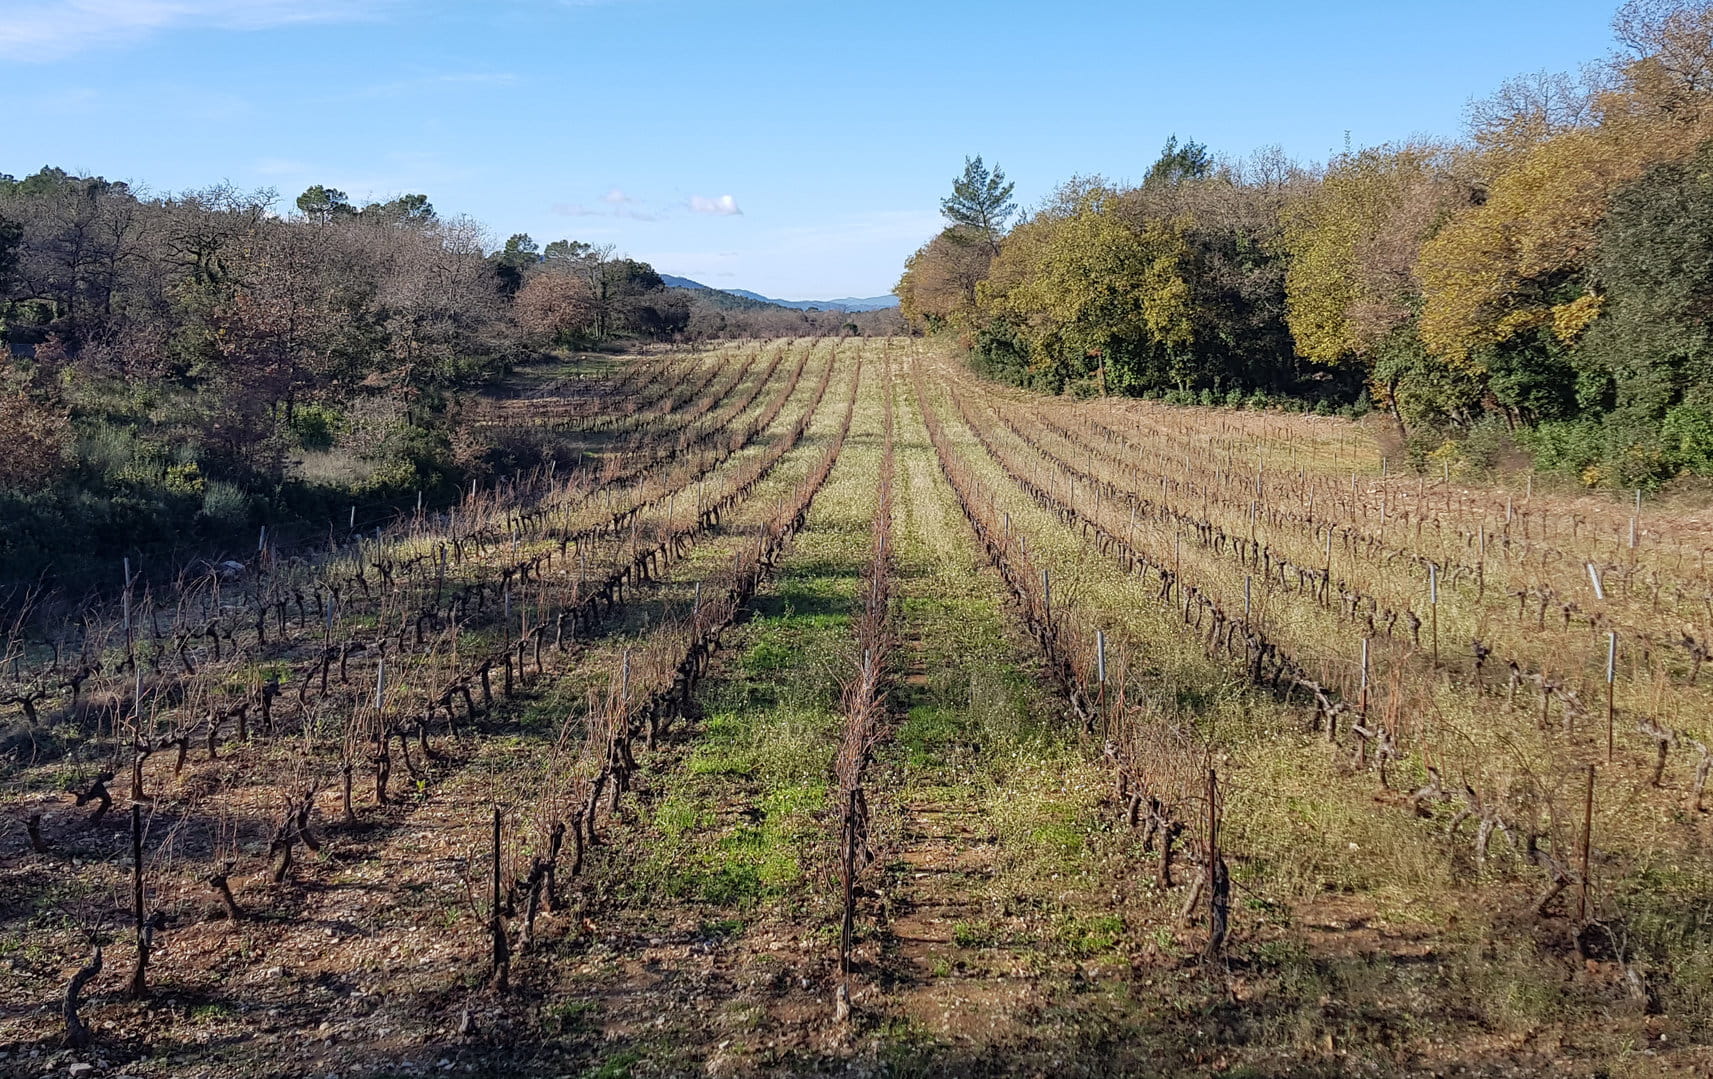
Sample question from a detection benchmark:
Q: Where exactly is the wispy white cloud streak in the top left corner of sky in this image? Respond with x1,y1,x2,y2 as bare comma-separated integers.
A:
0,0,397,60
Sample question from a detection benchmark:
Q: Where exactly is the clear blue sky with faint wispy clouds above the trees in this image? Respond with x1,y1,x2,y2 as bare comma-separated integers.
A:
0,0,1615,300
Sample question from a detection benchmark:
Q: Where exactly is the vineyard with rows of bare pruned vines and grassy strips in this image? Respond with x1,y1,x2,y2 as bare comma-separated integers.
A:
0,337,1713,1077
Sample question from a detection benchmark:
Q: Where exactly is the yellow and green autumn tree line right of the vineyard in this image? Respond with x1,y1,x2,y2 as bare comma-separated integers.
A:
898,0,1713,488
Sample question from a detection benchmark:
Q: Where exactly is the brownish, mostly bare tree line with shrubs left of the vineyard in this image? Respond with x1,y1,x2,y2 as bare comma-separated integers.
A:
0,168,870,581
